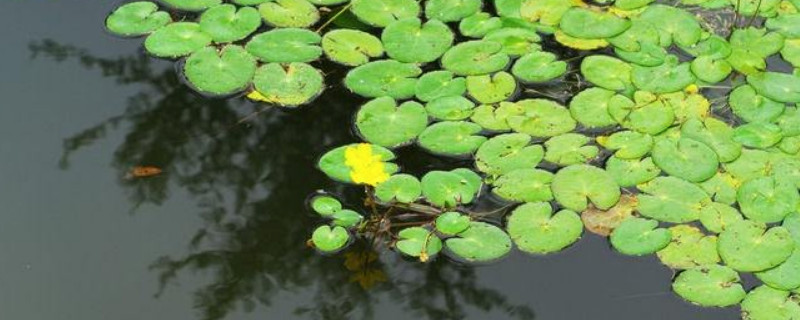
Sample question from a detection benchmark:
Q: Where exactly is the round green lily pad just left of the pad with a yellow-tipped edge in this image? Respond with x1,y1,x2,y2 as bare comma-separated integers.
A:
183,45,256,95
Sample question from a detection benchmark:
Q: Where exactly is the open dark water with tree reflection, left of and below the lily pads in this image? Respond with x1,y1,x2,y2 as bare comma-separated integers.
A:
0,0,738,320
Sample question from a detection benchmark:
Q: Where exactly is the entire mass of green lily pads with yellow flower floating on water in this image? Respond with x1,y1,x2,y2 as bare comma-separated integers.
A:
107,0,800,320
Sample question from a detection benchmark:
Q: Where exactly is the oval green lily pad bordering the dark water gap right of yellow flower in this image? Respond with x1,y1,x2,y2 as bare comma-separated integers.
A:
418,121,486,156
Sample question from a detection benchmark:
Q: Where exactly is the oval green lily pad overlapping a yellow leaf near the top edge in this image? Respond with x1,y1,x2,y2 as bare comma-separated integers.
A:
559,7,631,39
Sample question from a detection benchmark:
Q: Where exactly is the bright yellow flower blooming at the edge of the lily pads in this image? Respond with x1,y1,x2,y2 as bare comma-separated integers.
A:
344,143,389,186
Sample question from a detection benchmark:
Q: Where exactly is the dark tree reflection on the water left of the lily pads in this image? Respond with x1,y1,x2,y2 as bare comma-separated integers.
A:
30,40,534,319
